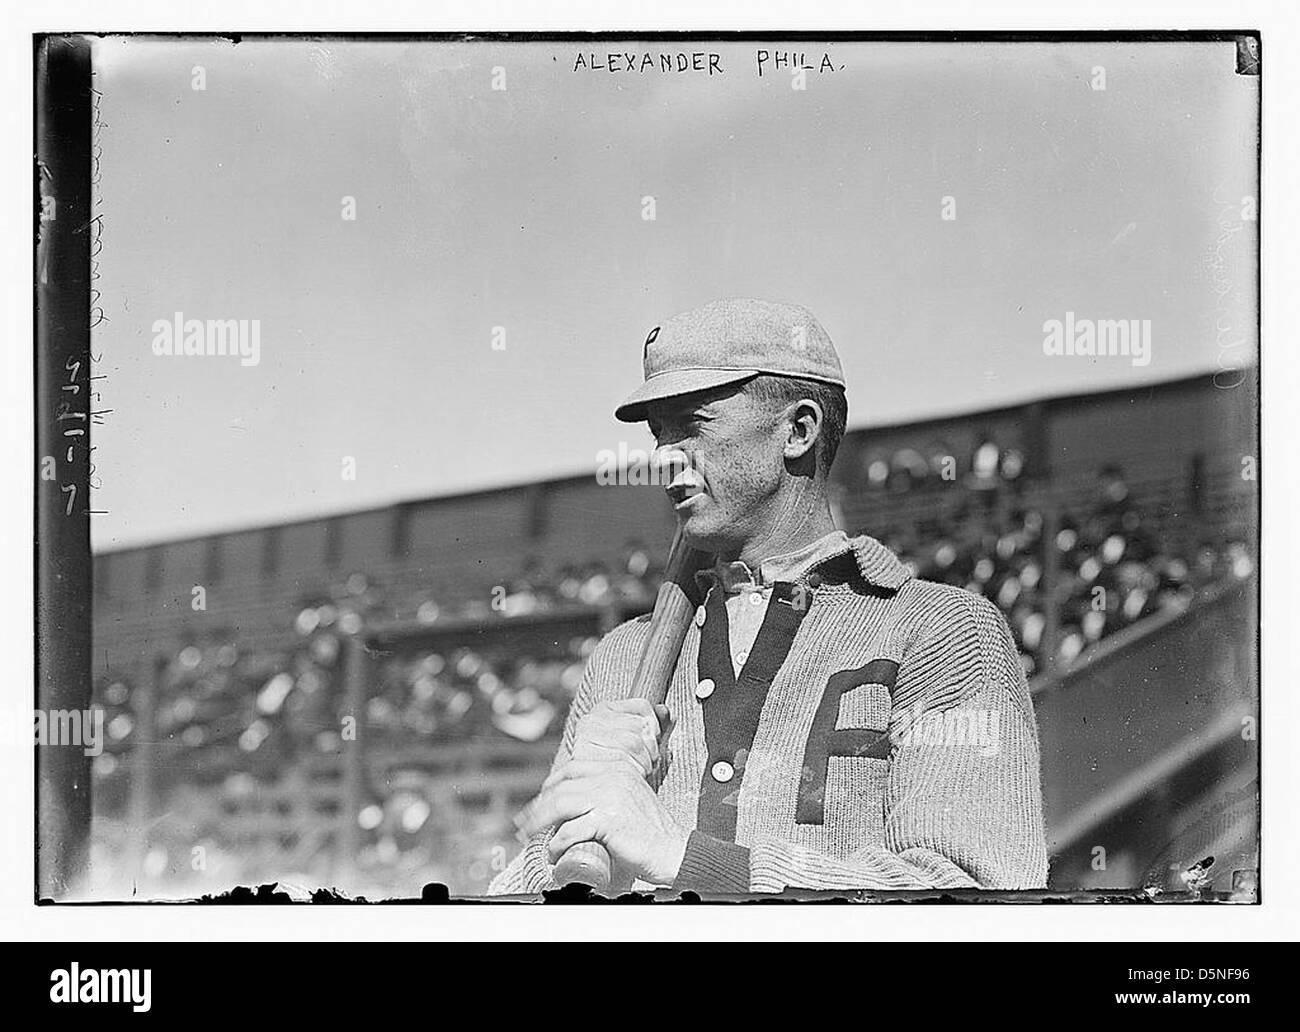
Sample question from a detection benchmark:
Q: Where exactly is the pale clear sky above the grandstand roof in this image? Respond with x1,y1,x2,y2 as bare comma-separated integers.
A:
92,36,1258,551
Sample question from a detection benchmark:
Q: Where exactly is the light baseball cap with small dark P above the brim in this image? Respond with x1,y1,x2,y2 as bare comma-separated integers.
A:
614,298,844,422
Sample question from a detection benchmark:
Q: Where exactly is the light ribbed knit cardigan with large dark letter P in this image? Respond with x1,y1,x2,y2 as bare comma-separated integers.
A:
489,537,1047,894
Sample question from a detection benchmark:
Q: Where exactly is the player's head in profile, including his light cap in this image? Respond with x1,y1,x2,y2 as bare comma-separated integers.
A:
614,299,848,565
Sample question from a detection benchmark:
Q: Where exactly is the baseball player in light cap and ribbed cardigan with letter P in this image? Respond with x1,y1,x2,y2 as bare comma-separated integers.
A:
491,299,1047,894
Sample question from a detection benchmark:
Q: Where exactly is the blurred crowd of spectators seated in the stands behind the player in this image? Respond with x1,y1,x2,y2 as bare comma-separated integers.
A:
89,446,1252,881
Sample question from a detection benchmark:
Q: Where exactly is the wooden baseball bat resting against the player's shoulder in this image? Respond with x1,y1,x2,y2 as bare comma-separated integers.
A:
555,526,711,892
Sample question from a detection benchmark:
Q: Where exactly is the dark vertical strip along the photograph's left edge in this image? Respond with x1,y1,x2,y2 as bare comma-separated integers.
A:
34,36,94,898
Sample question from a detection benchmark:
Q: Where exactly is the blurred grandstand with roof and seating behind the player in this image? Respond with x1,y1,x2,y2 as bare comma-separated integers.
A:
92,371,1256,896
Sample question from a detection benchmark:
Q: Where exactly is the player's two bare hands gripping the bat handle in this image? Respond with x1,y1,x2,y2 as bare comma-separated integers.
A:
519,699,688,885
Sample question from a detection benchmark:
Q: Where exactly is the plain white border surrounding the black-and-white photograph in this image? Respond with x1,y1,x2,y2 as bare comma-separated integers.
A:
0,0,1300,942
